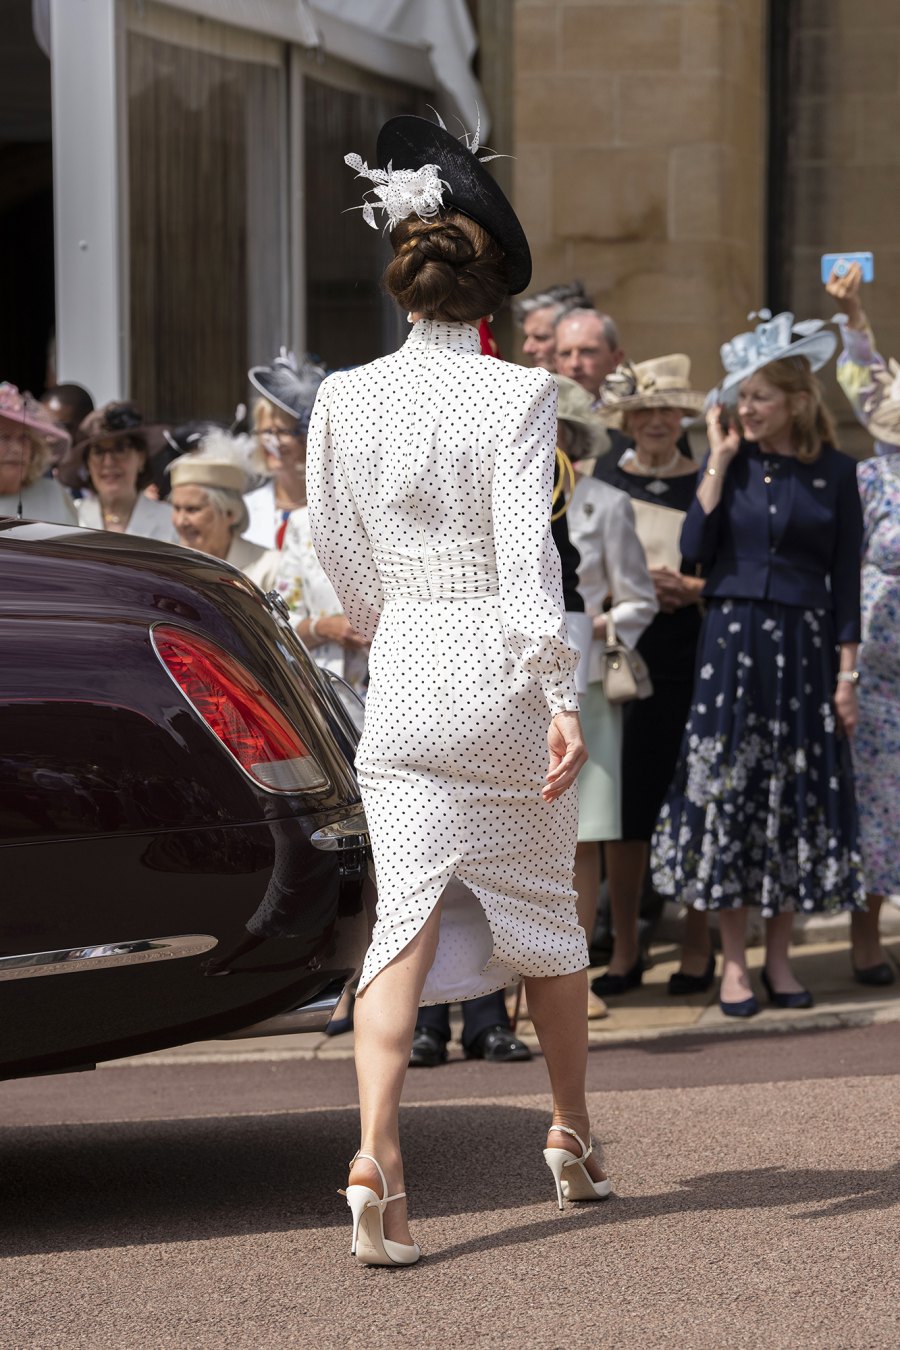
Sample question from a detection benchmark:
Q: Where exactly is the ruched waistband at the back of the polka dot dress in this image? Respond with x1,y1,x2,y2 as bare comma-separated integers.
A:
374,537,499,601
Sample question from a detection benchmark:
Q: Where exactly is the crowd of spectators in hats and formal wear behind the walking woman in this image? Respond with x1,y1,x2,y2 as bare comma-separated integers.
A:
0,257,900,1042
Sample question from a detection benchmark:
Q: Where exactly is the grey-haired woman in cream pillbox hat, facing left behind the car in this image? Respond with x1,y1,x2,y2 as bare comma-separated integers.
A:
169,432,278,590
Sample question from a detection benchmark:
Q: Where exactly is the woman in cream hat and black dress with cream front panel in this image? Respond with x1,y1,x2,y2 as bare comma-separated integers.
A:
592,352,714,998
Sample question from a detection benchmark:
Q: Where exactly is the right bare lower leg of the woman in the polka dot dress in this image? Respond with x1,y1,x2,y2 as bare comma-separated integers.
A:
525,971,606,1181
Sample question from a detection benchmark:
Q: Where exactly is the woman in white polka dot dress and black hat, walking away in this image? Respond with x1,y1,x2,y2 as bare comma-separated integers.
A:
308,117,610,1265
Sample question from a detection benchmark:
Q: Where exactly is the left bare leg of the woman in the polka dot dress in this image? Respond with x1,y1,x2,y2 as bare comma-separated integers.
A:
351,900,441,1245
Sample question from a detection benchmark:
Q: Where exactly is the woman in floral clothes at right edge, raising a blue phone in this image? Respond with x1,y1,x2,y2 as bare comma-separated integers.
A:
826,263,900,986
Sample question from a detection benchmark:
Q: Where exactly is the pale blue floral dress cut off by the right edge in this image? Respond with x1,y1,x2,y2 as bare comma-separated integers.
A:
853,447,900,895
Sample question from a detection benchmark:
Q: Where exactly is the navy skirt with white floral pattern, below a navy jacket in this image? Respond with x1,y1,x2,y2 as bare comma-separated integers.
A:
652,599,865,917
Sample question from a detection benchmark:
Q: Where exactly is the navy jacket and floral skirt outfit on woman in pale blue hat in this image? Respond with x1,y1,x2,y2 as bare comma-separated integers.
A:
652,443,865,918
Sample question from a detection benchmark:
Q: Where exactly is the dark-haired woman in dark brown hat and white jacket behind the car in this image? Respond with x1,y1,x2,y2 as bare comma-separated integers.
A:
73,402,178,544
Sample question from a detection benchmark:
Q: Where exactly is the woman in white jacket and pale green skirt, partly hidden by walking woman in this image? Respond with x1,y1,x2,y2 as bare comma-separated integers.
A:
556,375,658,1015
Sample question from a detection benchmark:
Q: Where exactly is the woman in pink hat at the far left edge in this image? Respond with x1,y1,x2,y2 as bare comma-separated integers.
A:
0,383,77,525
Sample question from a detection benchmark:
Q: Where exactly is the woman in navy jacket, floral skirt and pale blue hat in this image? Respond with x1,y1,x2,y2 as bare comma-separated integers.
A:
653,334,865,1017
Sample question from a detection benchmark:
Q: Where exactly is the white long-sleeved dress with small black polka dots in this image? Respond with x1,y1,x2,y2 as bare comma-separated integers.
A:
306,320,588,1003
